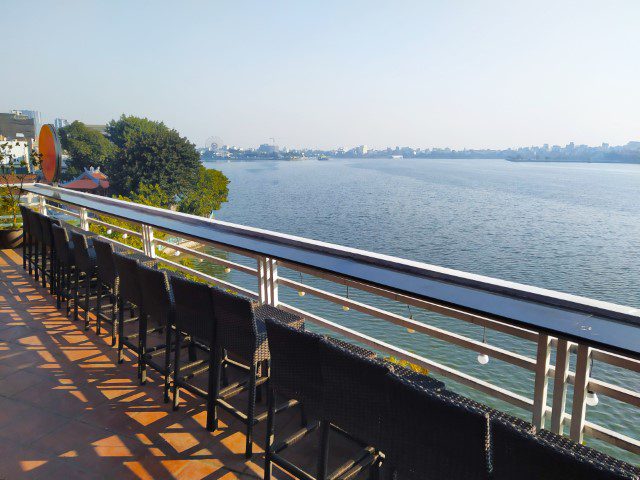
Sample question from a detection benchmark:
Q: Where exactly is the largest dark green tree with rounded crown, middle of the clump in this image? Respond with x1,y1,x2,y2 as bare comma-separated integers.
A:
107,115,201,203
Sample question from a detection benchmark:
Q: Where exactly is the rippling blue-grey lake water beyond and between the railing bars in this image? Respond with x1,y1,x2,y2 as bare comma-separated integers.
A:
202,159,640,463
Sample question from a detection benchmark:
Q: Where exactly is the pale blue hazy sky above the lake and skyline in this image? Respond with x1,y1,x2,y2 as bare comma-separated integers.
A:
0,0,640,148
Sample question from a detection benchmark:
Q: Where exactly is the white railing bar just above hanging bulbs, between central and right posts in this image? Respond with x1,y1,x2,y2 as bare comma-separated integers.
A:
278,277,536,371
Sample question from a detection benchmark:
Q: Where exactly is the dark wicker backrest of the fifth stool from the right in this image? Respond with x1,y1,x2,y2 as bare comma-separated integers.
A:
212,288,258,360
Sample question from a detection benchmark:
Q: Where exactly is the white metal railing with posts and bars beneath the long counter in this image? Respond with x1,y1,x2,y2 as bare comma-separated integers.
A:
26,185,640,463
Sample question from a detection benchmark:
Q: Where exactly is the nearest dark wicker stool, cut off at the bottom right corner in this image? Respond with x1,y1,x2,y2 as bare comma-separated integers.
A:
491,418,640,480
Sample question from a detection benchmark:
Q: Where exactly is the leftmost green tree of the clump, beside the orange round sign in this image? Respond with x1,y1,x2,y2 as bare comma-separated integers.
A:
59,120,117,178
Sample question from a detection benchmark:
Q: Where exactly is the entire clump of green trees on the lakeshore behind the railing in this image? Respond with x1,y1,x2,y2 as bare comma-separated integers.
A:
60,115,229,217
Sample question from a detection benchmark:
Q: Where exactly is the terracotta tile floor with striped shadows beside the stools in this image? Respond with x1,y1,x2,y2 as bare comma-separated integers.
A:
0,250,360,480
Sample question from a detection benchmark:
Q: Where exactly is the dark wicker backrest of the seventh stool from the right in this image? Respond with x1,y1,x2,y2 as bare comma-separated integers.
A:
137,263,175,326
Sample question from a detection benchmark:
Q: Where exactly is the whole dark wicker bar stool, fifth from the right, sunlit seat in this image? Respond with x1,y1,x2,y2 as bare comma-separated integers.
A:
210,288,304,458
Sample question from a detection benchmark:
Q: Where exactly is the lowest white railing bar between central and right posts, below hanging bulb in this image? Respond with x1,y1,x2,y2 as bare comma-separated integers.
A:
278,303,533,411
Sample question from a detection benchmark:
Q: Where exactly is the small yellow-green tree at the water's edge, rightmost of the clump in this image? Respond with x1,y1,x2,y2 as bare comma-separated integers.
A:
178,165,229,217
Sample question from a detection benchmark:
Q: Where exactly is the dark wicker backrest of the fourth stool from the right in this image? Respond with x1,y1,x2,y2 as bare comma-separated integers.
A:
265,318,323,413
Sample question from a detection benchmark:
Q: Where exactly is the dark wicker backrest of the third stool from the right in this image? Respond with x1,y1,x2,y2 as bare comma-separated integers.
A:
320,340,389,446
